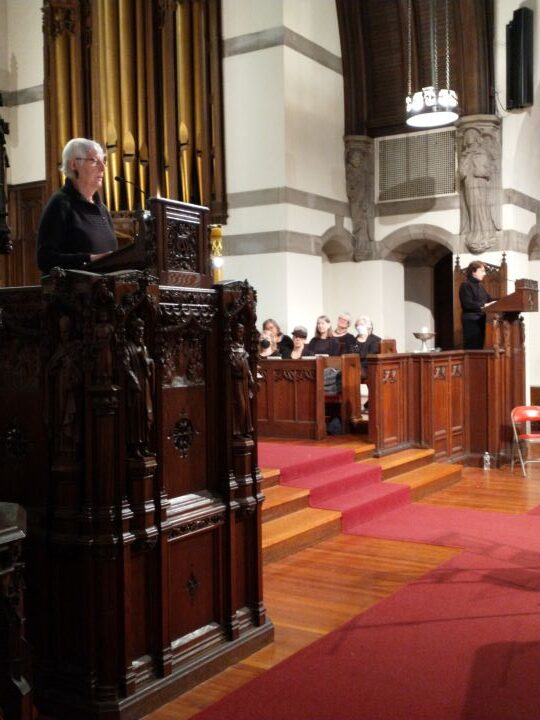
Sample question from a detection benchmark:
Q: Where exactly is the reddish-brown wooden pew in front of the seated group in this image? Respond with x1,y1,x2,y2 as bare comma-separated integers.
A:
257,354,360,440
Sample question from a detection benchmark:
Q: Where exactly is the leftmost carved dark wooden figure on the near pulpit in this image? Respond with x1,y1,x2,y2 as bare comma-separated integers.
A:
47,315,82,462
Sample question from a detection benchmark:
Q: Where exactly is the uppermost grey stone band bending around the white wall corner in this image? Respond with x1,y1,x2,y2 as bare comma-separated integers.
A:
223,25,343,75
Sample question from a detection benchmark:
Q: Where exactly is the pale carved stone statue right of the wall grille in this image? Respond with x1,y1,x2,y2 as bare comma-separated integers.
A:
458,125,501,253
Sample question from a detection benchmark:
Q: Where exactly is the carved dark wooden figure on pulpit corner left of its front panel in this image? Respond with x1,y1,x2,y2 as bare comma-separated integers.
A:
126,317,154,458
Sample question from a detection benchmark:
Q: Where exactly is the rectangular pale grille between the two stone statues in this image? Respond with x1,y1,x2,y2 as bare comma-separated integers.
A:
379,128,456,202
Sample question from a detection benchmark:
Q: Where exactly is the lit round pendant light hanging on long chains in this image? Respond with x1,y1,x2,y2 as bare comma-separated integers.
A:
405,0,459,128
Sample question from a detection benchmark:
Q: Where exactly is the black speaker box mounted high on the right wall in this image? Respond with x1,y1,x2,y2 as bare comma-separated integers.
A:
506,7,533,110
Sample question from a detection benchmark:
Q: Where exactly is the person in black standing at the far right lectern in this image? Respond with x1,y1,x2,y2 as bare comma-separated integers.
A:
459,260,494,350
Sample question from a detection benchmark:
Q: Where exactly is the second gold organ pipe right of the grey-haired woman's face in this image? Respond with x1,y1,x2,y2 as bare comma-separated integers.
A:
118,0,138,210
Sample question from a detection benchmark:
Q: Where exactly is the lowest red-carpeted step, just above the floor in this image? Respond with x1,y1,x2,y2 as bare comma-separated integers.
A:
310,483,410,532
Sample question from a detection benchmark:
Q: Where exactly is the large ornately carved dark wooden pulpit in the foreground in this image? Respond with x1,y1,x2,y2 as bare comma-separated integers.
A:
0,199,273,720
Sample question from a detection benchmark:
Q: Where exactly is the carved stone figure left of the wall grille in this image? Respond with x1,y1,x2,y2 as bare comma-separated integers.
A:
345,135,374,262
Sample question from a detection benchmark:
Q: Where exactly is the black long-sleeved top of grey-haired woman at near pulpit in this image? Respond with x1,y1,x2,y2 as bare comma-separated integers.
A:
37,179,118,273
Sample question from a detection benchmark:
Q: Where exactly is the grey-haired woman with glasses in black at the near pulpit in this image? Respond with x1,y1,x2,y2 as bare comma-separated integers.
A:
37,138,118,273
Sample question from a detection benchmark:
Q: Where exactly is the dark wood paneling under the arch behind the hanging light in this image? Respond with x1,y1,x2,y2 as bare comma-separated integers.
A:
336,0,494,137
